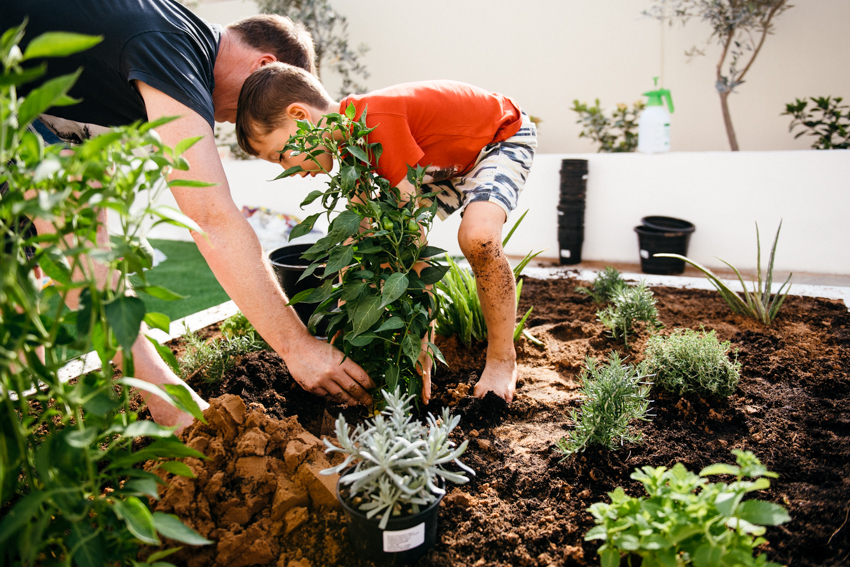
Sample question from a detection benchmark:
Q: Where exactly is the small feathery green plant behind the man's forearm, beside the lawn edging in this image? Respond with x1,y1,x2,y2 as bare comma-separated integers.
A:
180,332,268,384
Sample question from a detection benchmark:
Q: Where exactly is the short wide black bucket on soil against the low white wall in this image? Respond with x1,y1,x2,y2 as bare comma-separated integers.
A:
635,217,696,276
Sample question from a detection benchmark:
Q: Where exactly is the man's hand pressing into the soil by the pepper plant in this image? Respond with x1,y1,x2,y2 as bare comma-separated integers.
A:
284,332,375,405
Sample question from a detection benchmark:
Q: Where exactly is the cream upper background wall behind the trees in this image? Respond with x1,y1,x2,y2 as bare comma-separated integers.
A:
189,0,850,153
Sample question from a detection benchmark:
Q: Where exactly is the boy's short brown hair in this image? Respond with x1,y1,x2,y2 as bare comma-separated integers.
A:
236,62,333,156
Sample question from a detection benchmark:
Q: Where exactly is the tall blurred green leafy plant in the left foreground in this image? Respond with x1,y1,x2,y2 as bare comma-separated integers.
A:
0,24,210,565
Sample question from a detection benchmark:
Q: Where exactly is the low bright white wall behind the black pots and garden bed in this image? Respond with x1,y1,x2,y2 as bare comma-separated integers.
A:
142,150,850,274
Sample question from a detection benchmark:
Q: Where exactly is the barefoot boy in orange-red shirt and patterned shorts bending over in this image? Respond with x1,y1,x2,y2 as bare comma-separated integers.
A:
236,63,537,403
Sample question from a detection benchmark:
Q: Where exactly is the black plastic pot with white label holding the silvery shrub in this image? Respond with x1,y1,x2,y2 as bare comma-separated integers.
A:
336,478,444,565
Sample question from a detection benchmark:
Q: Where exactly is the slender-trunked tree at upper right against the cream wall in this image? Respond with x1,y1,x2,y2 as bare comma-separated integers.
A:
644,0,792,152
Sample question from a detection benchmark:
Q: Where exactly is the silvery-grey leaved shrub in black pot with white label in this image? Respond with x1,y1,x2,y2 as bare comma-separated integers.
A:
321,390,475,564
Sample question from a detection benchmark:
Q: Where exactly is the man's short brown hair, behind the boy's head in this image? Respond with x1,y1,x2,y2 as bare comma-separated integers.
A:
227,14,316,73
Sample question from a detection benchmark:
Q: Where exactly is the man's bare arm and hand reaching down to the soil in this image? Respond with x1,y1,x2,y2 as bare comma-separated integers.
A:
136,81,375,403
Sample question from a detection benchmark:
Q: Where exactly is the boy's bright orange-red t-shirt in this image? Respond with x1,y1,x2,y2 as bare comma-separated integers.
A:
339,81,522,186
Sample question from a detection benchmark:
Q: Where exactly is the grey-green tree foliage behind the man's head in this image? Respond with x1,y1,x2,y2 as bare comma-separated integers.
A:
257,0,369,97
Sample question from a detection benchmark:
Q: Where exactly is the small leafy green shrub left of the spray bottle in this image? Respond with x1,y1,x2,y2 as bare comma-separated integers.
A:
571,98,646,153
